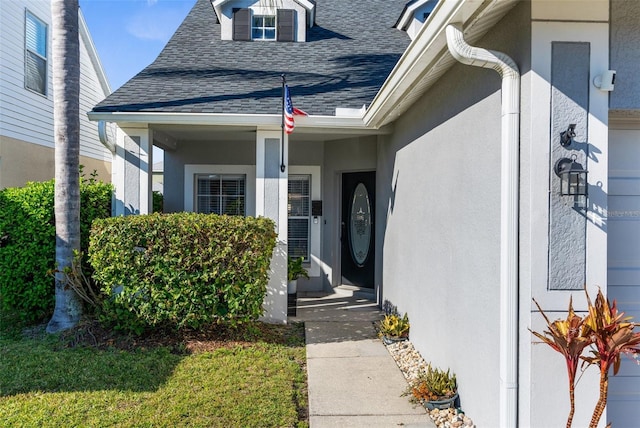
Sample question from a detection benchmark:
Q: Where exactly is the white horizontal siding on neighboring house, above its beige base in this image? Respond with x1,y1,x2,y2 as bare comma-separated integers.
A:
0,0,111,161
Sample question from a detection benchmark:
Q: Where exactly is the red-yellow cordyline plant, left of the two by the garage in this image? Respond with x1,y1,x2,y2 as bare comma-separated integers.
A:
529,299,592,428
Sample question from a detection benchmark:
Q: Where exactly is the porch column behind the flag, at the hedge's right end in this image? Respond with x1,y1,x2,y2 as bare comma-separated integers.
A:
256,130,289,323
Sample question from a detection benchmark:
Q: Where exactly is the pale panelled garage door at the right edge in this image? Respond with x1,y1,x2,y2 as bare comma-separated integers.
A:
607,130,640,427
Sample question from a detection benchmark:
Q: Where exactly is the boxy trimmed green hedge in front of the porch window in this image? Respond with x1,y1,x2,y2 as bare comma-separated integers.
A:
89,213,276,333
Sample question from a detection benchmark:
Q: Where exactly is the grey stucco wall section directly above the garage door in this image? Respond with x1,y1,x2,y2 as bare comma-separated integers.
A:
610,0,640,110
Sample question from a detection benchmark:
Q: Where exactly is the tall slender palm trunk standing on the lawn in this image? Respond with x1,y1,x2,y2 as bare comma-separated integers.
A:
47,0,82,333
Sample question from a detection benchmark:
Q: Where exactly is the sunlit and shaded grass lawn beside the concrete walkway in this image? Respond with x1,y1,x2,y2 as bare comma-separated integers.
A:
0,315,307,427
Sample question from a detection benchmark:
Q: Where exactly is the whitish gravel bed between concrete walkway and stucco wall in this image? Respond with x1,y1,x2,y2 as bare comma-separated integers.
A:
386,340,476,428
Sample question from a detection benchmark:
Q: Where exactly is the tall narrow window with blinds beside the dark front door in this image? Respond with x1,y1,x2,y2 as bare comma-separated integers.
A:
287,175,311,261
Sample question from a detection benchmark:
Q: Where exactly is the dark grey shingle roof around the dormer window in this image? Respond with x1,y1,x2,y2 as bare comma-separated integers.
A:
94,0,410,115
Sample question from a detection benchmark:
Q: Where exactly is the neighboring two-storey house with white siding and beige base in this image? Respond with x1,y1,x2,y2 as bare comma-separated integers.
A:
0,0,111,189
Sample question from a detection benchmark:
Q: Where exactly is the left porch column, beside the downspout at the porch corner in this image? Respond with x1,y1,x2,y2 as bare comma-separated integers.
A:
111,126,153,216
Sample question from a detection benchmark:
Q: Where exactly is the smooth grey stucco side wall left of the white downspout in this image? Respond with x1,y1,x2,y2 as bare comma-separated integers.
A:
378,3,530,426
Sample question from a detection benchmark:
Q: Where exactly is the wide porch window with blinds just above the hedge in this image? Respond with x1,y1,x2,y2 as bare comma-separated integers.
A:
195,174,246,216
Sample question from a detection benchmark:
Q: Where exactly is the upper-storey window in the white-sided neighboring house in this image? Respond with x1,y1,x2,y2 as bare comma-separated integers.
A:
24,11,47,95
